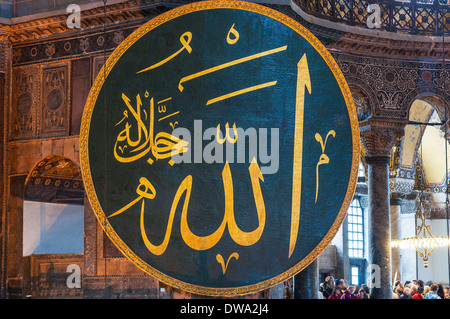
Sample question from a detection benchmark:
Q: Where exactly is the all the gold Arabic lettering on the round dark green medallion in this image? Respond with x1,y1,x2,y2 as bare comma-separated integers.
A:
108,24,336,274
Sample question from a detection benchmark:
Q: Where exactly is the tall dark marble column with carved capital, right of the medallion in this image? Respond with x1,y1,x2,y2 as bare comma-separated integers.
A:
360,120,404,299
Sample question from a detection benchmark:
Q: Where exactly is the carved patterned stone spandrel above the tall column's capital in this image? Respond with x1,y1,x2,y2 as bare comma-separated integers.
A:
333,53,450,120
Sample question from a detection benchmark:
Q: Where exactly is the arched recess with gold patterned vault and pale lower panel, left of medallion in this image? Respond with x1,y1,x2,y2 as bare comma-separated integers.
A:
23,155,84,256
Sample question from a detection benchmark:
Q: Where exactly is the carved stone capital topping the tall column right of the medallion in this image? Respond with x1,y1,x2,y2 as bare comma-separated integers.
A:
359,119,406,163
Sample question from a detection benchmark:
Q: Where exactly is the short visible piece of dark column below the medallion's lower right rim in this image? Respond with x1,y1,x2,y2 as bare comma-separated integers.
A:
293,259,319,299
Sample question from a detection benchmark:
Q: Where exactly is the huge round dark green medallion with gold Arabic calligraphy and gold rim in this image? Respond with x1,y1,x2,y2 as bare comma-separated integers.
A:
80,1,359,296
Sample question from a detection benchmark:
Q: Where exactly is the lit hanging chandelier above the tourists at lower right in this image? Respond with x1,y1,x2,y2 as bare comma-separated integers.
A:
391,192,450,268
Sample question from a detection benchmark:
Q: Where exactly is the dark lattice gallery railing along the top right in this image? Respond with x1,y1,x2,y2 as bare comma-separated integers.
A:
293,0,450,35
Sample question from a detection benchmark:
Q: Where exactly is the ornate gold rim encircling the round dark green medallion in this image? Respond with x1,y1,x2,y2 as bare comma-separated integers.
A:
80,1,360,297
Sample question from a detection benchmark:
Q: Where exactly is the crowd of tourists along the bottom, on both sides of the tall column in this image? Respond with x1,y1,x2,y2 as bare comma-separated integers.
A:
319,276,450,299
